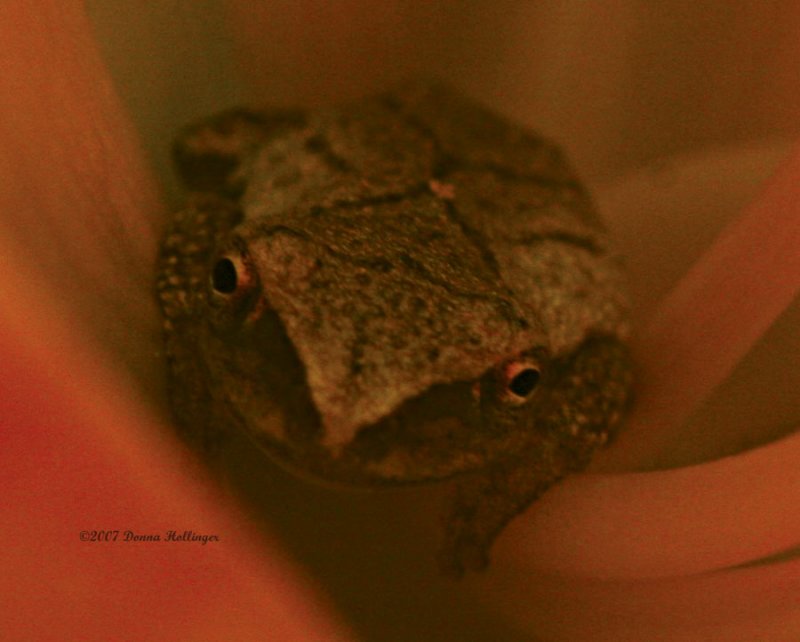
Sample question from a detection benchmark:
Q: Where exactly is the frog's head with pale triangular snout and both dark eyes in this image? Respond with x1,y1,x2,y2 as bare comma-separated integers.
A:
197,194,550,480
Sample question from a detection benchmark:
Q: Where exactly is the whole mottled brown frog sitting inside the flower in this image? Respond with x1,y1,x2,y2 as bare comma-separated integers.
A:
158,86,630,575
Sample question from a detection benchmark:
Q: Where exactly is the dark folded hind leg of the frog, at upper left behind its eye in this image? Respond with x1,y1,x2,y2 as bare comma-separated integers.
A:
172,108,305,197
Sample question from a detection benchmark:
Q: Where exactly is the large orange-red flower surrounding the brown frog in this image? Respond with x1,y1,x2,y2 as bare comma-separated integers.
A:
0,0,800,641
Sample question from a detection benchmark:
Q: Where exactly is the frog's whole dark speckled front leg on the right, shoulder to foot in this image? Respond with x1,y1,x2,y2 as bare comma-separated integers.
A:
440,337,631,577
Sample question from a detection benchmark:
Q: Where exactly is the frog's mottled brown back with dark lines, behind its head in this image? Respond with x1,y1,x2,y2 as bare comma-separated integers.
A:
242,84,627,353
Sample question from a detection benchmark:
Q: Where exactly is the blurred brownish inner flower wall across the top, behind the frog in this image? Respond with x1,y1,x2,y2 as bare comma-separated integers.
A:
86,0,800,198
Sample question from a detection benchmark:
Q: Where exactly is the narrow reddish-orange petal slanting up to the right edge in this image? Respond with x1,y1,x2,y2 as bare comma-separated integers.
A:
609,141,800,461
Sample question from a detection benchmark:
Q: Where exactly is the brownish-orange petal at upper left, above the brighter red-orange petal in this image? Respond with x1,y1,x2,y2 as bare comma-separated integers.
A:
0,2,164,390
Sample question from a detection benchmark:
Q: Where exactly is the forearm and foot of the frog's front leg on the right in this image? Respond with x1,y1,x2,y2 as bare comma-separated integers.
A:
439,462,558,578
